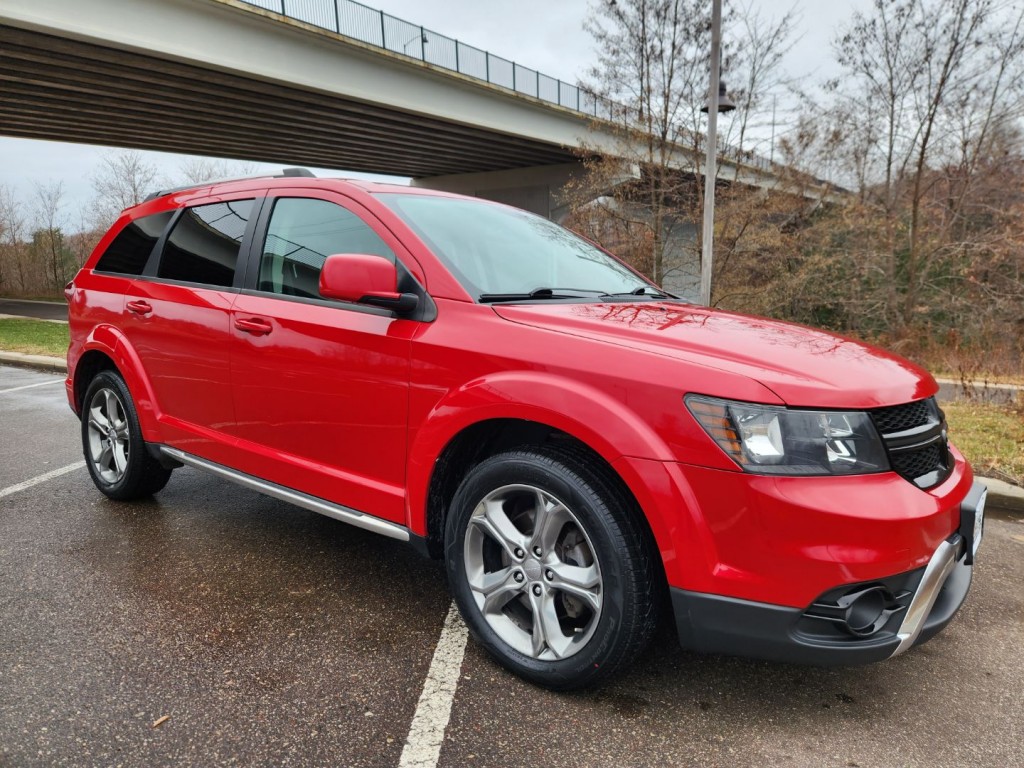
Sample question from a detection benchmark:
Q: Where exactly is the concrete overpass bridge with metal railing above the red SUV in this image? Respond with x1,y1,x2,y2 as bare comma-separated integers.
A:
0,0,790,210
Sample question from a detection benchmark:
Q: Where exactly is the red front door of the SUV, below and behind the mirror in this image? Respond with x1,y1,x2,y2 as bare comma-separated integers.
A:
230,189,420,522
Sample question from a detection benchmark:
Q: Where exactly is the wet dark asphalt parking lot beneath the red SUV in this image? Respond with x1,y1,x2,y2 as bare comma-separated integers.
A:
0,367,1024,768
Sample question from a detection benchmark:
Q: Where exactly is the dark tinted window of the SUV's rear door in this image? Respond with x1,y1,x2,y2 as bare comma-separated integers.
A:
157,200,253,287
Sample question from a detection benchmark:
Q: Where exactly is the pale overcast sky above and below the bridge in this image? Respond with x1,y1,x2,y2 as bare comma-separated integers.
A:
0,0,870,227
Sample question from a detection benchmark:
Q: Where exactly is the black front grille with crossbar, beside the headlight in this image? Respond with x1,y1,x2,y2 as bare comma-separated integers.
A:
870,397,952,488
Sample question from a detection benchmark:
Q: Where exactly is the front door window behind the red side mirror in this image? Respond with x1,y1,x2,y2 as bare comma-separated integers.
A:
258,198,395,298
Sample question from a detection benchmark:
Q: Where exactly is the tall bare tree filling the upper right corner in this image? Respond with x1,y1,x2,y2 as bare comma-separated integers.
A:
834,0,1024,333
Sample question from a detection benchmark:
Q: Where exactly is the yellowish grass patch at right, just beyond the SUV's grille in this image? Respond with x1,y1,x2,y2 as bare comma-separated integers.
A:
942,402,1024,485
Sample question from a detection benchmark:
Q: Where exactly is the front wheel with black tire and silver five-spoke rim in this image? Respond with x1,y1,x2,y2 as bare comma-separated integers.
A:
444,446,659,690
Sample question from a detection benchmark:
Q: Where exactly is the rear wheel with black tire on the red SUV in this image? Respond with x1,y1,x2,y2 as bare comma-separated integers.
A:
82,371,171,501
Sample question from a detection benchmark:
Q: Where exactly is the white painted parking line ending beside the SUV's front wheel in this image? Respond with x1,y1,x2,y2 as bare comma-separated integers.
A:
398,603,467,768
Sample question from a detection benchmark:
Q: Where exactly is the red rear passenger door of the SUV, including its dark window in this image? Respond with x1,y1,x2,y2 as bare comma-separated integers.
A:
123,194,257,464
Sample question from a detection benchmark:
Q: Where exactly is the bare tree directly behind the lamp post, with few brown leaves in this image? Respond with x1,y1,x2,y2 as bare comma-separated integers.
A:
571,0,794,290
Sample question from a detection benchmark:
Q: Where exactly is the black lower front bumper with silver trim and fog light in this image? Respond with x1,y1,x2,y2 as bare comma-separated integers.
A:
672,482,985,666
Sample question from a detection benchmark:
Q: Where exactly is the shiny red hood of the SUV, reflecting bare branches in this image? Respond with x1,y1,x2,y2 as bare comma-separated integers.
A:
494,302,938,409
